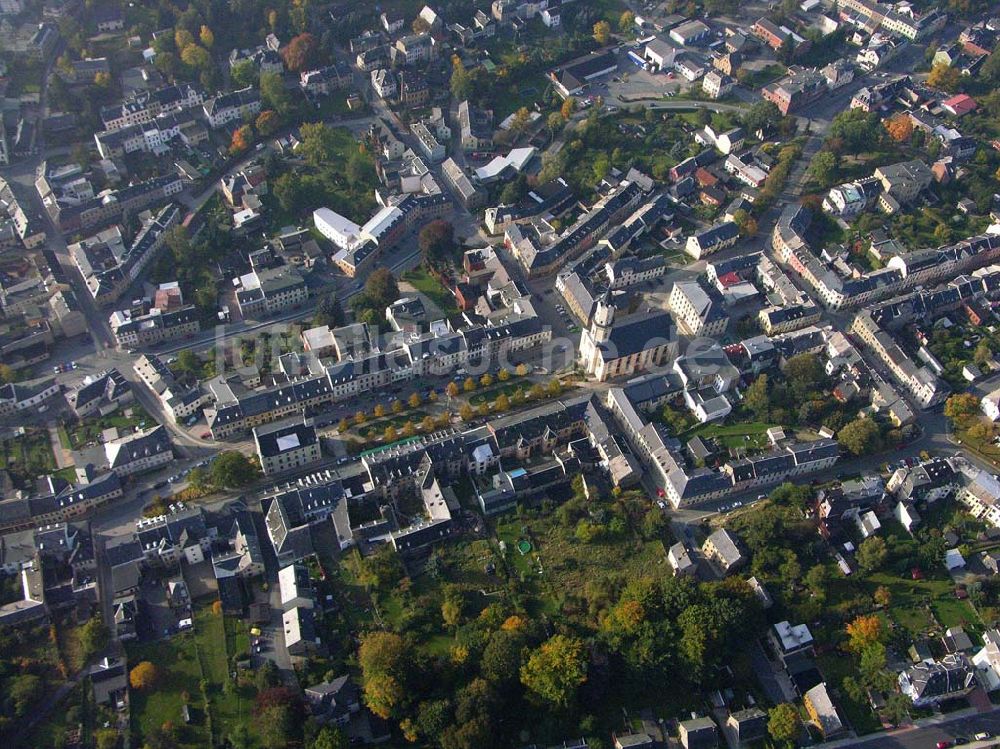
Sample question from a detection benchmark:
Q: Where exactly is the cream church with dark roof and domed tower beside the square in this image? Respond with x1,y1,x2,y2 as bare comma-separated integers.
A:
580,294,677,382
